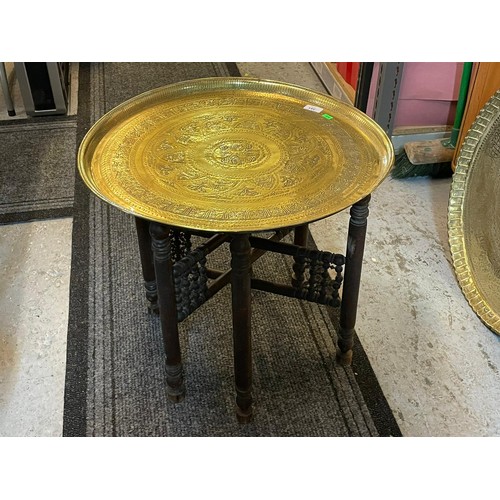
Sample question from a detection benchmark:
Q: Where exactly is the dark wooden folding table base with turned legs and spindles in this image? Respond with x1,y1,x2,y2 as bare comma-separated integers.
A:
136,196,370,423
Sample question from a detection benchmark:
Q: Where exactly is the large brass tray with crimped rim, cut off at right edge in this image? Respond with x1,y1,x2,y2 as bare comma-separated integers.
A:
448,90,500,334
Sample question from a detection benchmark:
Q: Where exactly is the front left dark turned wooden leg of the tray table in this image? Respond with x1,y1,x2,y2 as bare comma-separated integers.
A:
150,222,185,402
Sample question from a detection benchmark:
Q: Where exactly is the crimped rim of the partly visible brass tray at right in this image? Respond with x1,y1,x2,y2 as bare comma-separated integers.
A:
448,90,500,335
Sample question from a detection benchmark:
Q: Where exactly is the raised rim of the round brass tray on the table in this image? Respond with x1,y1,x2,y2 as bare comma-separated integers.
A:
77,76,395,233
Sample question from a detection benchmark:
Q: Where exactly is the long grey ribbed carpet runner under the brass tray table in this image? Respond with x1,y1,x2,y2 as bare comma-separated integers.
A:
64,63,400,436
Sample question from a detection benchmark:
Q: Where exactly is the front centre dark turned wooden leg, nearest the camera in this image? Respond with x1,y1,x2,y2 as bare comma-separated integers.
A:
230,234,252,423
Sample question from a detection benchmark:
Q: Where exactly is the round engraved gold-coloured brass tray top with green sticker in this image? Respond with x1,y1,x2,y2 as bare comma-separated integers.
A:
78,77,394,232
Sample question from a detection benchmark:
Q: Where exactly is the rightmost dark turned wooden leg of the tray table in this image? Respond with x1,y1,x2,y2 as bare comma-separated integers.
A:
337,196,370,365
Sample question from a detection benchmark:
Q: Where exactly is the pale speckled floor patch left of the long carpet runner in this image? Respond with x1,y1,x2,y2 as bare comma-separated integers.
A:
0,219,72,436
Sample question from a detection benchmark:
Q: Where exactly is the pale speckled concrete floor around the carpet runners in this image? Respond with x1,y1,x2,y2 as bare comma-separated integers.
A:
0,63,500,436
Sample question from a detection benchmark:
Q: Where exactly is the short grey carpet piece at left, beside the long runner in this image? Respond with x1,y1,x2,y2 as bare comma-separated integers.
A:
0,117,77,224
